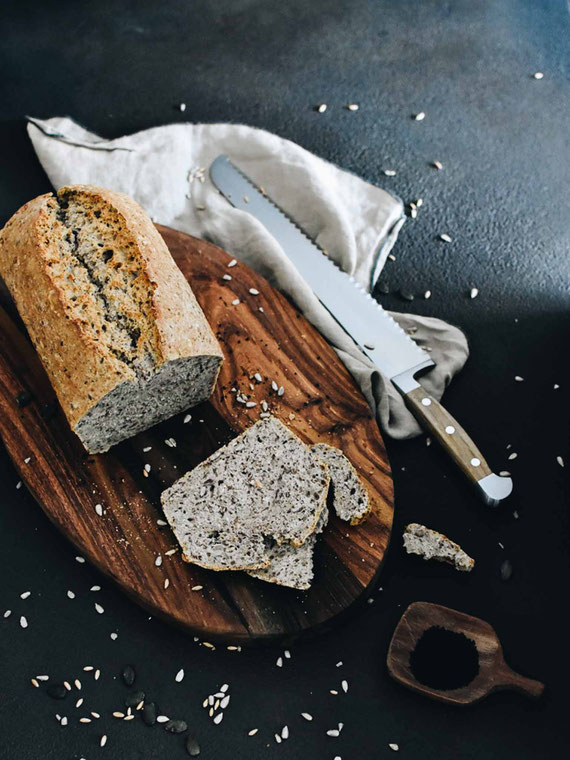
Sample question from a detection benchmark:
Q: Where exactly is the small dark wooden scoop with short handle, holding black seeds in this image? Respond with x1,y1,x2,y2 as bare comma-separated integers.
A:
387,602,544,705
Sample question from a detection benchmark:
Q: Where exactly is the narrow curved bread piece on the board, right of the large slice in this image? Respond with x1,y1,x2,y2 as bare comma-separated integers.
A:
311,443,371,525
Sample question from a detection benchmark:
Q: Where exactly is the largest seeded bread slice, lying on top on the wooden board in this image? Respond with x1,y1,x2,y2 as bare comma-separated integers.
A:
161,417,330,570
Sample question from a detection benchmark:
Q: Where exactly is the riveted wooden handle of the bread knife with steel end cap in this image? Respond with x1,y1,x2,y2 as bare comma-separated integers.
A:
403,382,512,506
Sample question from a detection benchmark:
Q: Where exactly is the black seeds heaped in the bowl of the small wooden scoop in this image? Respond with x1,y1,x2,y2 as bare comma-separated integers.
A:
410,626,479,691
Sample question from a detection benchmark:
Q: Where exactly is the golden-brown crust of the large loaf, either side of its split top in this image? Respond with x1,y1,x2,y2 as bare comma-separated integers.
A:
0,185,223,429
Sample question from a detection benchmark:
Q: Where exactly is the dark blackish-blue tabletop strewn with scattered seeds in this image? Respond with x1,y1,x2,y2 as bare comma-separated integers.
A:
0,0,570,760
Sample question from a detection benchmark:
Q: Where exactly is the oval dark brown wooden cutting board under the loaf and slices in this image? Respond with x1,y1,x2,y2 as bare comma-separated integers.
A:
0,227,393,644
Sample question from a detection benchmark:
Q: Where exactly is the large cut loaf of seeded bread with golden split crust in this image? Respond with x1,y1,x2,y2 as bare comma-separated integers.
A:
0,185,223,453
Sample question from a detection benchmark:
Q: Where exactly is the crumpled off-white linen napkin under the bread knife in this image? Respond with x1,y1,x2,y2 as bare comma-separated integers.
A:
28,117,469,438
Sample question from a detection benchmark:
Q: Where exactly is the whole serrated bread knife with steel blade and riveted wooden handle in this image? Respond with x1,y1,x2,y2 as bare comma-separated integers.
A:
210,155,513,506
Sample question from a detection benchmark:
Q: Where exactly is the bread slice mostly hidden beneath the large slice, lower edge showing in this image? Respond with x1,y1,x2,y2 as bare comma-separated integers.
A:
248,507,329,591
